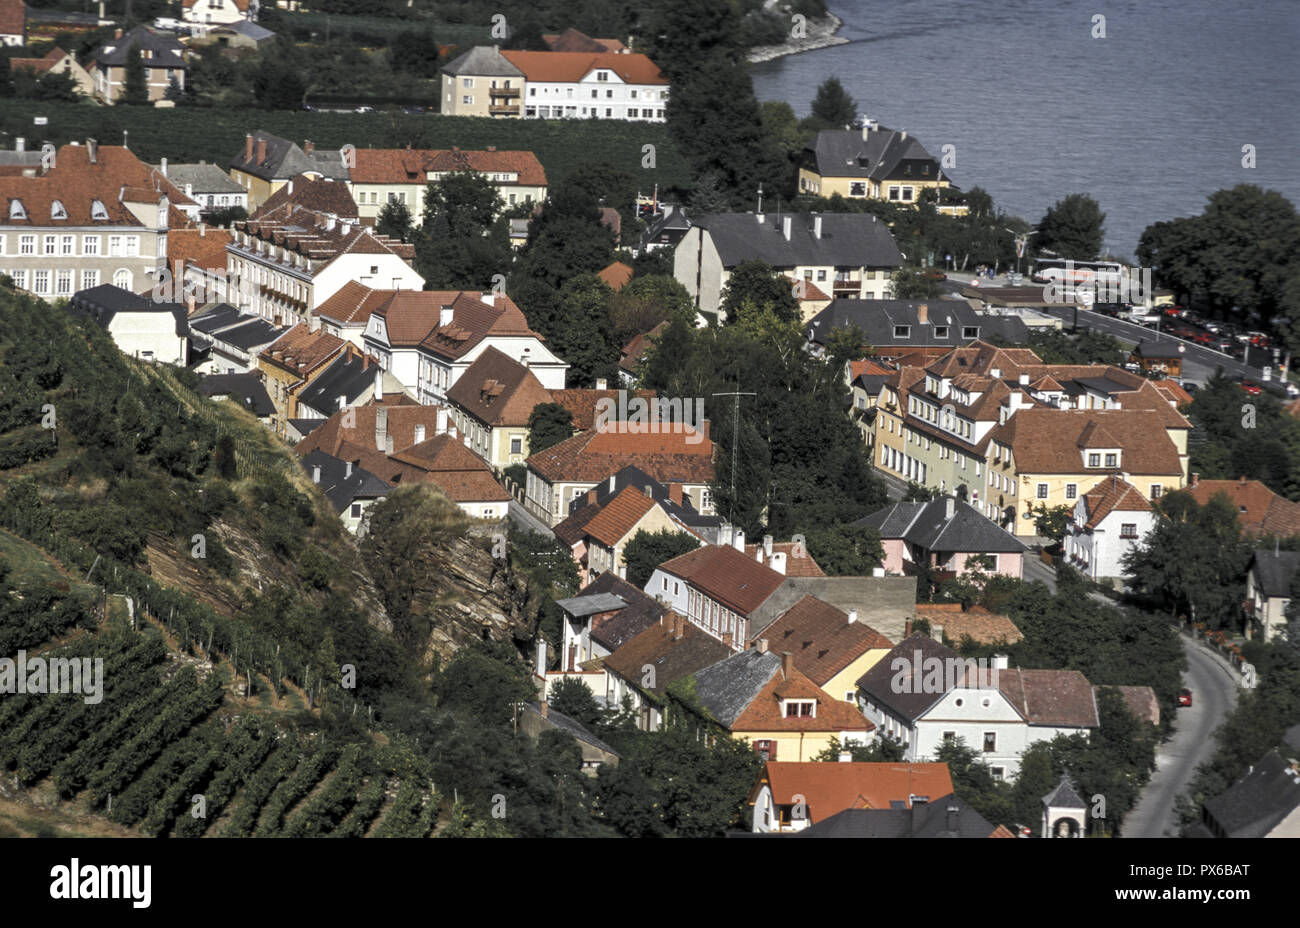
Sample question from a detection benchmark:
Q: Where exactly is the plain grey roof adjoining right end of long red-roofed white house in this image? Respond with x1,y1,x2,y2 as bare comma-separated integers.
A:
749,577,917,641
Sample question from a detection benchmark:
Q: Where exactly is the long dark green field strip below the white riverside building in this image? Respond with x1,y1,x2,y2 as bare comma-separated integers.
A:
0,100,690,192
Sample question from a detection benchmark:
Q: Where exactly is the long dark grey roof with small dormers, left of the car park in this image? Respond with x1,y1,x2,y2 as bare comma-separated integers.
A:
803,298,1030,348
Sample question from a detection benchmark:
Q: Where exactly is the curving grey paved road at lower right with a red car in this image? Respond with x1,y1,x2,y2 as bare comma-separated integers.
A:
1123,636,1240,838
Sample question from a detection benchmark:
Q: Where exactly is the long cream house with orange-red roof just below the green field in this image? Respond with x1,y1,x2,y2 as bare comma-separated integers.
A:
347,147,547,225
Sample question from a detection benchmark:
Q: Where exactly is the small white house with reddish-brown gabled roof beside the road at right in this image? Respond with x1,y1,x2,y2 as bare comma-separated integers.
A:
1063,476,1160,580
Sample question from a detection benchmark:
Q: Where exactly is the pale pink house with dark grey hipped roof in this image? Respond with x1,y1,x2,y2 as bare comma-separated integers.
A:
854,496,1027,580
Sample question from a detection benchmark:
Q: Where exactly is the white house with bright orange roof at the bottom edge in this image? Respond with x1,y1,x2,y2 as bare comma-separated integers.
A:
748,756,953,834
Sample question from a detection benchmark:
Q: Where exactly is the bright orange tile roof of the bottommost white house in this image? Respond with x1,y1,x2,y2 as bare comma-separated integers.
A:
750,760,953,821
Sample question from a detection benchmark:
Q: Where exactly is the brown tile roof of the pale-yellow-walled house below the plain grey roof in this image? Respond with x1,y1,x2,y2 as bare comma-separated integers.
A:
763,595,893,686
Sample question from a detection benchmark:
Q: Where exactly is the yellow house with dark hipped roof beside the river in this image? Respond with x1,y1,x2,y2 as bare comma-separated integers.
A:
800,122,969,216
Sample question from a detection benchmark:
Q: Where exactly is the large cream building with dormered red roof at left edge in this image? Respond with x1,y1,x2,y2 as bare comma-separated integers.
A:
0,139,198,299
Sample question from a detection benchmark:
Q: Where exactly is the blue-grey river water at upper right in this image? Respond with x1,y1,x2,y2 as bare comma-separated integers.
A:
753,0,1300,257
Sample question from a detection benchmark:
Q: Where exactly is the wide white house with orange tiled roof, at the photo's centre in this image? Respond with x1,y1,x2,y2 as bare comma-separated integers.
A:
525,420,714,525
